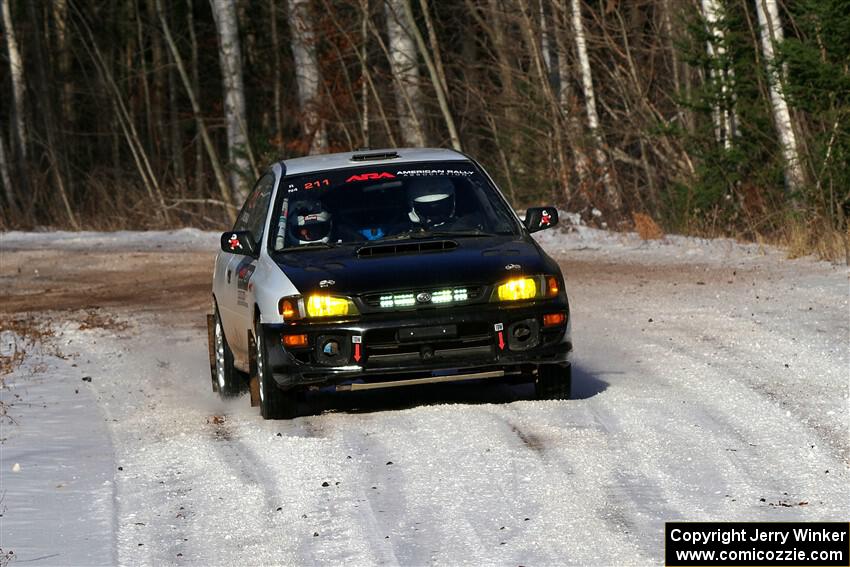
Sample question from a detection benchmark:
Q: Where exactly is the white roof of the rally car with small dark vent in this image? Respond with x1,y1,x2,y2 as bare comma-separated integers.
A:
281,148,469,175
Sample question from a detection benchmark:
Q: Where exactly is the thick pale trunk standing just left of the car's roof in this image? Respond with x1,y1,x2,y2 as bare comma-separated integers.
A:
210,0,249,203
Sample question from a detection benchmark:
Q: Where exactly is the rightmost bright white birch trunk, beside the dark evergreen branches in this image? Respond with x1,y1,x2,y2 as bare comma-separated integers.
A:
755,0,805,198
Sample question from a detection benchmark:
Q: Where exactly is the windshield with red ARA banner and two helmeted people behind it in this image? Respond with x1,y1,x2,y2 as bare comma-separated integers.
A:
273,162,517,251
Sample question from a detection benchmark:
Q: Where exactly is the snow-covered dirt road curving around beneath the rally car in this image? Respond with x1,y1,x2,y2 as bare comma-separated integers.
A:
0,232,850,565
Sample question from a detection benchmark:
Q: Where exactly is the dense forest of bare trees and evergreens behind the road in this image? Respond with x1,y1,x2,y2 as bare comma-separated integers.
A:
0,0,850,259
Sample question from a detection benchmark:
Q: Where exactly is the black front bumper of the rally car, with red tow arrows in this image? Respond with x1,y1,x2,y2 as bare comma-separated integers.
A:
263,298,572,388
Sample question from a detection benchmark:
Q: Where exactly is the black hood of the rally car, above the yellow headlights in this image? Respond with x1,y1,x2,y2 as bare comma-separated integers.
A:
275,236,557,295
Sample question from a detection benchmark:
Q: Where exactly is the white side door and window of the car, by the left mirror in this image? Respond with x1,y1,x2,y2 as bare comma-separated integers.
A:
224,172,275,361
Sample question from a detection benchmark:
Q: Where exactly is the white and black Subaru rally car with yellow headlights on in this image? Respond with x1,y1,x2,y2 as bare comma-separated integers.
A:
208,149,572,419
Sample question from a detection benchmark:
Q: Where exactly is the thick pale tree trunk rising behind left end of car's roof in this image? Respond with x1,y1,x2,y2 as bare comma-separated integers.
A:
287,0,328,153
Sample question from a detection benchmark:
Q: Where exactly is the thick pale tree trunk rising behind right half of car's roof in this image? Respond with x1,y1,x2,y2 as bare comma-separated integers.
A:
384,0,425,147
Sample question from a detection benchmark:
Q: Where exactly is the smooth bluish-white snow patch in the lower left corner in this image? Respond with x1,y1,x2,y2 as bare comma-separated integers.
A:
0,326,115,565
